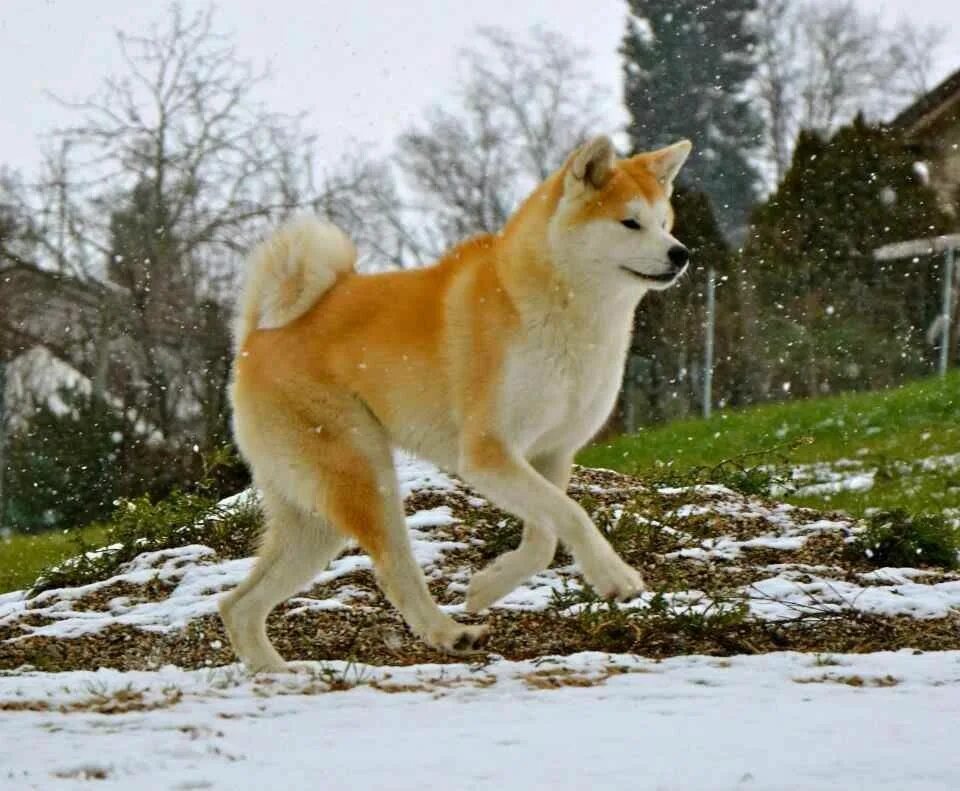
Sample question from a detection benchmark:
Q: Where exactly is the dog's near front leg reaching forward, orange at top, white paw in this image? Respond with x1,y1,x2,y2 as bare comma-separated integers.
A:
459,435,644,601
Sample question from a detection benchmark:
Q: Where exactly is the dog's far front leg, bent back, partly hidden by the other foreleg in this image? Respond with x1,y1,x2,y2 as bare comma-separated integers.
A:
467,453,573,612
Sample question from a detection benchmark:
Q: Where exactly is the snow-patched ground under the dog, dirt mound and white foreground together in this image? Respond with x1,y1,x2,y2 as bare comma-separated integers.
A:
0,459,960,791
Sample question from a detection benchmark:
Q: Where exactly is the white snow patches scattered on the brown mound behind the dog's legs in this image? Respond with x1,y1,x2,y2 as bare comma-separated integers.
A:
0,455,960,638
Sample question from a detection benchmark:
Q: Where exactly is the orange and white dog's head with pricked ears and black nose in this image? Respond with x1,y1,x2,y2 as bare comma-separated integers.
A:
549,137,691,291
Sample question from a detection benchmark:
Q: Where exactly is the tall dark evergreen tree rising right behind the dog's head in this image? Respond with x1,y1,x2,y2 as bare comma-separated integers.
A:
620,0,762,238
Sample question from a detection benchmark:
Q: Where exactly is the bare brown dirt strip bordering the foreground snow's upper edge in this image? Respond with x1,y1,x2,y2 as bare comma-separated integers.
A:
7,608,960,671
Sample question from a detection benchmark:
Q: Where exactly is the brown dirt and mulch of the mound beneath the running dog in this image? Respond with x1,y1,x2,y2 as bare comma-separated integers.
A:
0,469,960,672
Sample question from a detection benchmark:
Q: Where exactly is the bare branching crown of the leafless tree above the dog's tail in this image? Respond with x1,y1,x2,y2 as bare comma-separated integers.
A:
48,5,313,286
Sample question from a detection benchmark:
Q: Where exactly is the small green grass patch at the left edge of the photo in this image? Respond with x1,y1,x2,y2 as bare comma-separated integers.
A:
0,525,108,593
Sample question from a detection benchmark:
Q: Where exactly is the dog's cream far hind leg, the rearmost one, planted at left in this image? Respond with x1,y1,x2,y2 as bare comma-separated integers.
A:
220,488,347,672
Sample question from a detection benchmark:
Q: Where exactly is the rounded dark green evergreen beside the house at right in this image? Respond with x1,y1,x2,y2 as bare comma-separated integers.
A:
744,117,949,395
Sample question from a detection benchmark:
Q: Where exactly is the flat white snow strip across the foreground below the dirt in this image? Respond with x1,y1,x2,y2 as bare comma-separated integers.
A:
0,651,960,791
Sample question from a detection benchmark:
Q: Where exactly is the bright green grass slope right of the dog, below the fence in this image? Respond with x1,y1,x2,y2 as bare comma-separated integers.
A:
577,371,960,514
